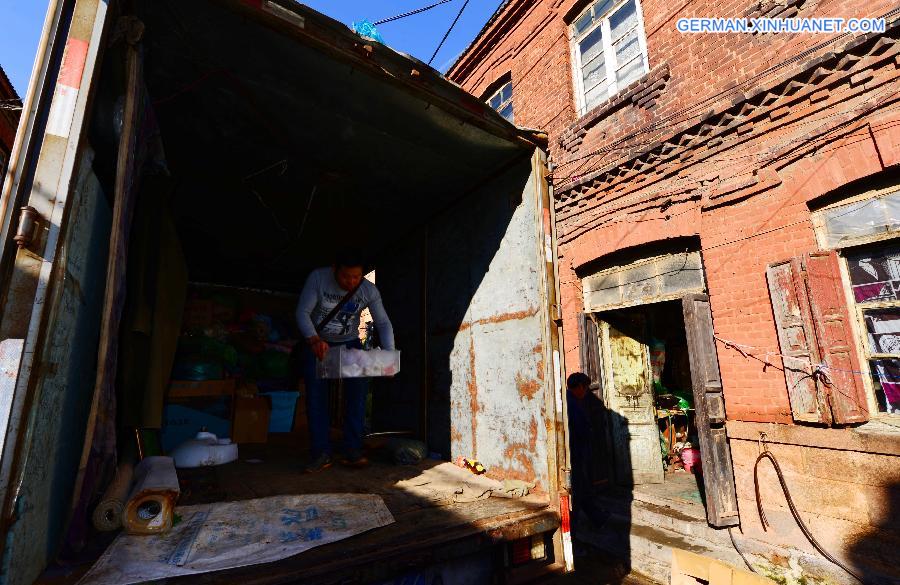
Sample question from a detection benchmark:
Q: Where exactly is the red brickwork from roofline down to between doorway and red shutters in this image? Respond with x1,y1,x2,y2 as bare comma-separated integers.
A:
449,0,900,423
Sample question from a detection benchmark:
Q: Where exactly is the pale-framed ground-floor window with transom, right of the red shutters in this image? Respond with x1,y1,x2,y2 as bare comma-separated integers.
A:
813,187,900,414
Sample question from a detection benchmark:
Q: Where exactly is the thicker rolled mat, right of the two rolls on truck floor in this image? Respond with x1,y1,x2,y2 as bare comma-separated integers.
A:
123,457,180,534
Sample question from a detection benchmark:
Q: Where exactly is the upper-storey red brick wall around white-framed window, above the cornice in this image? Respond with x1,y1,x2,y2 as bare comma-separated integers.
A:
448,0,896,162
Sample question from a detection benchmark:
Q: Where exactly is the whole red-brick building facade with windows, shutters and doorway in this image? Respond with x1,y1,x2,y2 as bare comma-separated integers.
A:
448,0,900,583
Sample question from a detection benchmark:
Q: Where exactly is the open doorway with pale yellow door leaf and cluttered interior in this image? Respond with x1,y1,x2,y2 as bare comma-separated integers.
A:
593,300,704,504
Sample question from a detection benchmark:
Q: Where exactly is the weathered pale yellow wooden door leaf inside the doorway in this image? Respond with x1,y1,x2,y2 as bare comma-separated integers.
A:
600,312,663,485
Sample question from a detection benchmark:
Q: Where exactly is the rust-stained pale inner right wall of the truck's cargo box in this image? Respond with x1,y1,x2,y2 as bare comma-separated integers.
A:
427,154,555,491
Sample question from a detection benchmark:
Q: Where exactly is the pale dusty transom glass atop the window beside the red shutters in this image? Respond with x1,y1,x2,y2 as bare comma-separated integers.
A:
823,192,900,247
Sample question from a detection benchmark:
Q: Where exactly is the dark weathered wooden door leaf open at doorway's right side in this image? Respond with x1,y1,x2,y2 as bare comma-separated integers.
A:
682,294,740,528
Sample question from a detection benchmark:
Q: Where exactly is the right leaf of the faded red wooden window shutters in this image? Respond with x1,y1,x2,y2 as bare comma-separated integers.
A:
804,251,869,424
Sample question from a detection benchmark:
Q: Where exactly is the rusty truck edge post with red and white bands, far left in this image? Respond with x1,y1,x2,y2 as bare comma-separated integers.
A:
0,0,107,583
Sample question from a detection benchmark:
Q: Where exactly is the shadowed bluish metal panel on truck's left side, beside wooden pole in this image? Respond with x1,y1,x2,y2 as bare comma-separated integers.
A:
2,152,111,584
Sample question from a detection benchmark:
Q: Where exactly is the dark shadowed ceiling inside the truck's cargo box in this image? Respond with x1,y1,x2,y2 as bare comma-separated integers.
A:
141,0,533,290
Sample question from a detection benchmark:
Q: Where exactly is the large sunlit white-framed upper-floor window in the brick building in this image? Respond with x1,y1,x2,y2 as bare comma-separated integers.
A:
571,0,650,114
